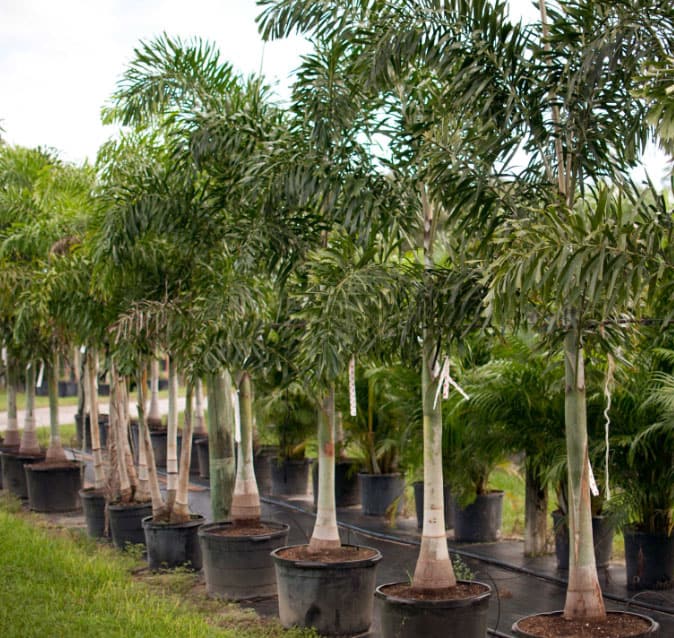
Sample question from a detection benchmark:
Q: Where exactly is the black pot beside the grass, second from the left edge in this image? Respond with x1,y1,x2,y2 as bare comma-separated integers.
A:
23,461,84,512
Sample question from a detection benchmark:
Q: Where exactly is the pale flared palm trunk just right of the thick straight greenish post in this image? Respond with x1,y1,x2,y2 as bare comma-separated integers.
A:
232,371,260,525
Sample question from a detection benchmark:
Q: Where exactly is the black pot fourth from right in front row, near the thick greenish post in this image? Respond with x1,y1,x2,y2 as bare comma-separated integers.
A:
199,521,289,600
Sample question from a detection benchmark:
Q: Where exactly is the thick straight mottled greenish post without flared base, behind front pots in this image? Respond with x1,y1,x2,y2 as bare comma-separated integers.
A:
207,370,235,521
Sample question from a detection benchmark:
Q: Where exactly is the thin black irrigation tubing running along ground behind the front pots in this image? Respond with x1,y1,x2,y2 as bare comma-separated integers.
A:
261,496,674,624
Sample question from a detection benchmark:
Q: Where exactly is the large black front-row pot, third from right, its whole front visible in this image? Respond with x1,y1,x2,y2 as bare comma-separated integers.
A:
271,548,381,636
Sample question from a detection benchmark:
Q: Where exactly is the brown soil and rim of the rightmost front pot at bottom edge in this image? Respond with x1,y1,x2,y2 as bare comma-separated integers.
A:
513,611,660,638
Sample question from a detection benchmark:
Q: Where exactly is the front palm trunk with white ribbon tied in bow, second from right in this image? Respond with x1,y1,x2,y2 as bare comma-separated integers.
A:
412,335,456,591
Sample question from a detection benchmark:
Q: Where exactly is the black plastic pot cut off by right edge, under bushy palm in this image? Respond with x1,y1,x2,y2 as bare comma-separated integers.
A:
623,525,674,589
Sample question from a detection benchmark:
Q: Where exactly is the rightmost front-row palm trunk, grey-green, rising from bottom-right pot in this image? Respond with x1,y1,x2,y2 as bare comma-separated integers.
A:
564,325,606,620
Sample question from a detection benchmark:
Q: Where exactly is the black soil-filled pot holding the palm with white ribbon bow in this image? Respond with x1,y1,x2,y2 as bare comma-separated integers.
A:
375,581,491,638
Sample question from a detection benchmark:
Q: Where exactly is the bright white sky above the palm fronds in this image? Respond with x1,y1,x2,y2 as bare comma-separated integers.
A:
0,0,665,181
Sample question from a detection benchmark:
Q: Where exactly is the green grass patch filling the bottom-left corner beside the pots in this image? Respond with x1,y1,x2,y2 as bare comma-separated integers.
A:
0,496,315,638
